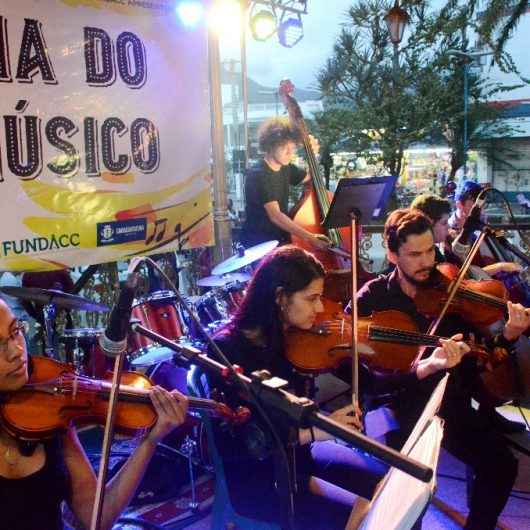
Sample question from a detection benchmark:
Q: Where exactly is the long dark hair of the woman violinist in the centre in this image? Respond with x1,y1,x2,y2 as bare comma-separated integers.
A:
229,245,325,348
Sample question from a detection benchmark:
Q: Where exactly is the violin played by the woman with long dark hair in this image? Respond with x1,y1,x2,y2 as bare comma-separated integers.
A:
286,300,492,373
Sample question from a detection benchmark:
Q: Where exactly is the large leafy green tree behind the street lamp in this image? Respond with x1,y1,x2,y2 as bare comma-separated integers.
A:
316,0,513,175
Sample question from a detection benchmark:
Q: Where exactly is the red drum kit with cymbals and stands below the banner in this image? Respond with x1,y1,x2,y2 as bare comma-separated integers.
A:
0,241,278,508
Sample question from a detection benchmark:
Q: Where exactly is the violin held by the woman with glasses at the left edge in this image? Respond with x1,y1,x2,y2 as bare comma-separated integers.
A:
0,357,250,441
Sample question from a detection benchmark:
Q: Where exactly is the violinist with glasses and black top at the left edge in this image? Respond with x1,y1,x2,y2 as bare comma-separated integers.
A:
0,300,187,530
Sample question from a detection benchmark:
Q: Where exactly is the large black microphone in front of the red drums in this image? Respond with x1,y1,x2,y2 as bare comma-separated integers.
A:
98,258,143,357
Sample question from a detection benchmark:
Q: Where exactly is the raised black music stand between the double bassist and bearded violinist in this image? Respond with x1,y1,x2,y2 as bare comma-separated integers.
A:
322,175,398,412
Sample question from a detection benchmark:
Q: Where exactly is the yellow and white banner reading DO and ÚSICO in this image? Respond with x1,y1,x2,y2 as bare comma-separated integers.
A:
0,0,213,271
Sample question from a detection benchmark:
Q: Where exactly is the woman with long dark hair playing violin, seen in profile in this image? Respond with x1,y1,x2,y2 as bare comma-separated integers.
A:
208,246,386,530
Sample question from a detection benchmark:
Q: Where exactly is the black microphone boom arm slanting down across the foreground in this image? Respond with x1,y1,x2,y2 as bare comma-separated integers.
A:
131,322,433,482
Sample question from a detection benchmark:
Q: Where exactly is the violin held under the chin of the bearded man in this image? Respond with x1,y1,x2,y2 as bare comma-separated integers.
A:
414,263,508,327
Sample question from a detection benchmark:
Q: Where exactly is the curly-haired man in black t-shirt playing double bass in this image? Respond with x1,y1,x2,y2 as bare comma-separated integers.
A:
241,117,329,250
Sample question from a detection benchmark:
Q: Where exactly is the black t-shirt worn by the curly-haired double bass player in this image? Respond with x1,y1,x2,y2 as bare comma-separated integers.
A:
241,160,306,246
